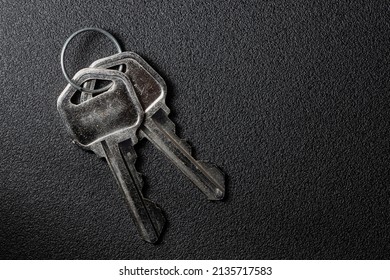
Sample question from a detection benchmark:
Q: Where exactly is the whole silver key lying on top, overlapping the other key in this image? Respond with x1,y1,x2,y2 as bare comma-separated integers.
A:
57,68,165,243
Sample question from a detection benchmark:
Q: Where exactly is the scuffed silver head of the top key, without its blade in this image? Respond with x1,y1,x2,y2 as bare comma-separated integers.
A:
57,68,143,154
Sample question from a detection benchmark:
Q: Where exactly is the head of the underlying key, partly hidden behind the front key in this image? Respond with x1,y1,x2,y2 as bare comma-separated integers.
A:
83,52,169,116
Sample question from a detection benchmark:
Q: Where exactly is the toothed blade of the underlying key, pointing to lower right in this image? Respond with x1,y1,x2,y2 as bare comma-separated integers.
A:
140,110,225,200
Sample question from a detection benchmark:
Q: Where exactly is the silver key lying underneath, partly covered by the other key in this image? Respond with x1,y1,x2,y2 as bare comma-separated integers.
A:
82,52,225,200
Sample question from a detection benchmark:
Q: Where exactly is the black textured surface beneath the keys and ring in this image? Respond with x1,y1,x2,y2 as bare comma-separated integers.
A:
0,0,390,259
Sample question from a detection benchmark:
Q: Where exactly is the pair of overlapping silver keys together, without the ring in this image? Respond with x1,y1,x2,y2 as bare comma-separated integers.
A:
57,49,225,243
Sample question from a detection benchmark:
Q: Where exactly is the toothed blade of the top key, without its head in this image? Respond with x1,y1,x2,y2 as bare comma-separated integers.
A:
101,140,165,243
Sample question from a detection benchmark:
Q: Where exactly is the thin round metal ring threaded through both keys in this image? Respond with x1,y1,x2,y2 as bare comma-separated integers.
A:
61,27,122,93
